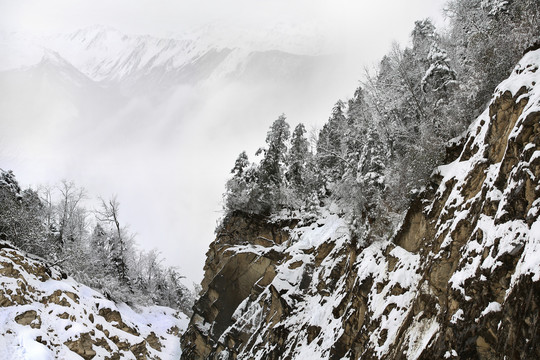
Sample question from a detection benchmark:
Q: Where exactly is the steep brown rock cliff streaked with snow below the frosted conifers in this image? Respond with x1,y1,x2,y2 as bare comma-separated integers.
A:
182,50,540,359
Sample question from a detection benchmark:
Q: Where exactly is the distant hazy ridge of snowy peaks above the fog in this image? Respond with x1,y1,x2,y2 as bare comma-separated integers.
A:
0,26,336,83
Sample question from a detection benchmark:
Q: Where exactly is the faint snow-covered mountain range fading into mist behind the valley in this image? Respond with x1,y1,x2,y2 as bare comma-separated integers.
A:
0,25,338,84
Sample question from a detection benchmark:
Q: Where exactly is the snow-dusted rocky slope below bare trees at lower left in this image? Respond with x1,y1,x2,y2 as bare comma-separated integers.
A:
0,242,187,360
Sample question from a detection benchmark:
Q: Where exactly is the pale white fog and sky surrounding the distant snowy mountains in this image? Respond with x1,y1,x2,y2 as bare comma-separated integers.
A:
0,0,448,282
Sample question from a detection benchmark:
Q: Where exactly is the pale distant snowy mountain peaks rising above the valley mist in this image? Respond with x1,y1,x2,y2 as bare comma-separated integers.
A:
0,22,334,83
